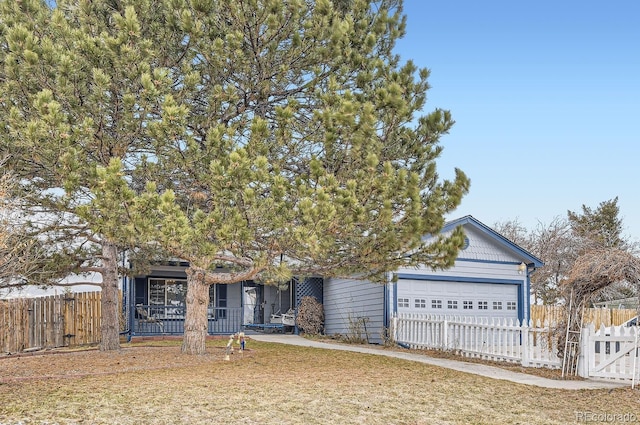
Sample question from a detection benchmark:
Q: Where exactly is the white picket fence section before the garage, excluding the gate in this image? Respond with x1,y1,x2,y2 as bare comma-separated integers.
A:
392,314,562,368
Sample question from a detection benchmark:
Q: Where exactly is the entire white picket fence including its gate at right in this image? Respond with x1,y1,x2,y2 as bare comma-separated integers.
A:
392,313,640,385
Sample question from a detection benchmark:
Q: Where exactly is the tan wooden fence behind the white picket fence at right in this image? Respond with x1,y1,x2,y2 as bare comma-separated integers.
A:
531,305,638,329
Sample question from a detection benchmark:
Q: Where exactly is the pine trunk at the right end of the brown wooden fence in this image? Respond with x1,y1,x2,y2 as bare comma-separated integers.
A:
100,243,120,351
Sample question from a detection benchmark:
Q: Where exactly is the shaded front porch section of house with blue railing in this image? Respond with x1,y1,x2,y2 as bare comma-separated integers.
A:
123,261,323,336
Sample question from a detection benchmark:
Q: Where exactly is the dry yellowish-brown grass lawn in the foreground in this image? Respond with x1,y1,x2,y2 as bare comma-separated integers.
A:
0,340,640,425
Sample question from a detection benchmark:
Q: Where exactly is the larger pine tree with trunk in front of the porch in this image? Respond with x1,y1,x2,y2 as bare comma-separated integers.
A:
127,0,469,353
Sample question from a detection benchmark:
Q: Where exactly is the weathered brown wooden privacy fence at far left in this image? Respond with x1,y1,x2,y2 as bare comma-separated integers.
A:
0,292,100,353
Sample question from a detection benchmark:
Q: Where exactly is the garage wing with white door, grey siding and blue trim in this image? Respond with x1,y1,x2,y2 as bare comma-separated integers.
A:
323,216,543,343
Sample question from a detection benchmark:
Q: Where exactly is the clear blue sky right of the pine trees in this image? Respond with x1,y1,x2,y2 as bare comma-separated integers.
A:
396,0,640,241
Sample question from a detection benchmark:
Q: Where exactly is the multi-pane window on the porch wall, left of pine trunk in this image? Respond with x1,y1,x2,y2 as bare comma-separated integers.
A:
148,279,187,317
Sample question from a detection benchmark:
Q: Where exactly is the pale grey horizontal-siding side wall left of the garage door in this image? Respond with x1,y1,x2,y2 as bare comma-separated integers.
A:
323,279,386,344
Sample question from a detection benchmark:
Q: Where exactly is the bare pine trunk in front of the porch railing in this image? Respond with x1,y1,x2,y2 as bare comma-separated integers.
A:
182,267,209,354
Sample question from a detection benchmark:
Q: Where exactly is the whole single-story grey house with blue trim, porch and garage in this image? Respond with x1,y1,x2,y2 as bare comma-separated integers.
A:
124,216,543,343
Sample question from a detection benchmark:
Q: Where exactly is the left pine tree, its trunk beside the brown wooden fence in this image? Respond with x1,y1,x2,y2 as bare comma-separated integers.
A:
0,0,182,350
